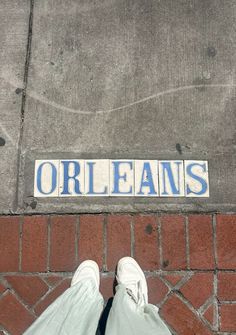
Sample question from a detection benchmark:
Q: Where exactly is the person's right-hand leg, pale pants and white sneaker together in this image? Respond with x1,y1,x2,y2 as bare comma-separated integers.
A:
106,257,171,335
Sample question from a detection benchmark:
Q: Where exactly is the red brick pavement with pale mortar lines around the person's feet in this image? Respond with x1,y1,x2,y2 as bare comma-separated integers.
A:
0,214,236,335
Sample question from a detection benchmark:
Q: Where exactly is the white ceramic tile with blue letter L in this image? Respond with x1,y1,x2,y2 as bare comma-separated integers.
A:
85,159,109,197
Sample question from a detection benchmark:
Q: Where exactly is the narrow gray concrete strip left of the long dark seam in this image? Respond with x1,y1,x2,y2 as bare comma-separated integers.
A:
0,0,30,214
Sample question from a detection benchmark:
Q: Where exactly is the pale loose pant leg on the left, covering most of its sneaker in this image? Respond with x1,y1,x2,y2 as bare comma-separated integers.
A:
24,280,104,335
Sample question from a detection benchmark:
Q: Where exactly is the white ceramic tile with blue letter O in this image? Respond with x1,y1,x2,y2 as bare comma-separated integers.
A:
34,160,59,197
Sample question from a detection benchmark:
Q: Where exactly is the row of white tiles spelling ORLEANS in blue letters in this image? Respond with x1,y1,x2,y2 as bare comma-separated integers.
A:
34,159,209,198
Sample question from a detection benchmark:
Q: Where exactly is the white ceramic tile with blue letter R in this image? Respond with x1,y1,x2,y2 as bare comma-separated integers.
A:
59,159,84,197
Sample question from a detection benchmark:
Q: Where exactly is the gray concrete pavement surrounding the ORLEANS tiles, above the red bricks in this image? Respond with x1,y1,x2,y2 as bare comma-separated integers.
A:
0,0,236,213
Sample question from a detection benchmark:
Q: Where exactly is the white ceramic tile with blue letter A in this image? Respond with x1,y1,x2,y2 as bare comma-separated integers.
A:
134,160,159,197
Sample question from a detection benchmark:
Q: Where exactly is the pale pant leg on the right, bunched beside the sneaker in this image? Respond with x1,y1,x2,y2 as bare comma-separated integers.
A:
106,284,171,335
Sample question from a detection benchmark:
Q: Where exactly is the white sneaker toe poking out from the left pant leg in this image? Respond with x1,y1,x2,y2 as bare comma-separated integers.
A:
70,260,100,289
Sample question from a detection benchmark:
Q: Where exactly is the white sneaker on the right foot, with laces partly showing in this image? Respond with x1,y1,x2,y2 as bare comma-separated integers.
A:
116,257,148,306
